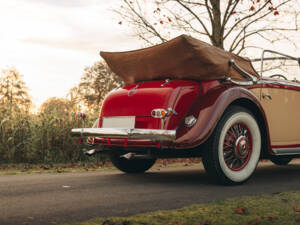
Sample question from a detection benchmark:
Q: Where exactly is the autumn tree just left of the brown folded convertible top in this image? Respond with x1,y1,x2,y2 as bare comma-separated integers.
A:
69,61,123,113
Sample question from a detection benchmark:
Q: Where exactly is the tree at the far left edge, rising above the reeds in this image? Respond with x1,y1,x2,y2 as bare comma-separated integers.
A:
0,67,32,114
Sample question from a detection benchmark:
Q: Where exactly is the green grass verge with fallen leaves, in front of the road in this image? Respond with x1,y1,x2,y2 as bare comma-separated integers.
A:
64,191,300,225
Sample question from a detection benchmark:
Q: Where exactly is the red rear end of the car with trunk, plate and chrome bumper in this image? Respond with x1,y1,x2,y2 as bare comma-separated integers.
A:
72,79,205,149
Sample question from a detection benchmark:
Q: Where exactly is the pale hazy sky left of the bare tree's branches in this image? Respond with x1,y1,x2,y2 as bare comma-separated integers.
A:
0,0,141,106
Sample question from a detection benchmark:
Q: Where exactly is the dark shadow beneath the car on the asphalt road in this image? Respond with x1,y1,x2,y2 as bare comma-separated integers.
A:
106,161,300,188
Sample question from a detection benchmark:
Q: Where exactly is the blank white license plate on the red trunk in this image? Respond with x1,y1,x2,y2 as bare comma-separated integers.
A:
102,116,135,128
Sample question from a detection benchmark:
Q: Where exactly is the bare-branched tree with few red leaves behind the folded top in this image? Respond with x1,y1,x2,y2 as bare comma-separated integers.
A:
115,0,300,54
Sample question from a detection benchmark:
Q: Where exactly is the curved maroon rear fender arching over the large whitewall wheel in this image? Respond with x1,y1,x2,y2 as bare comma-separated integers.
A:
174,85,272,157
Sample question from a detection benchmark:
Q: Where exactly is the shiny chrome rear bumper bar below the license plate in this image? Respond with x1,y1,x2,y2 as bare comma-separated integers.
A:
71,128,176,141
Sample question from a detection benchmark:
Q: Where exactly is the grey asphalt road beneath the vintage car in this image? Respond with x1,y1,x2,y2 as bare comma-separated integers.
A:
0,160,300,225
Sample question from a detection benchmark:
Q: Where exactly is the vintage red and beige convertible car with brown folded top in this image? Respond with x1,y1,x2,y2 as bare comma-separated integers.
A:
72,35,300,184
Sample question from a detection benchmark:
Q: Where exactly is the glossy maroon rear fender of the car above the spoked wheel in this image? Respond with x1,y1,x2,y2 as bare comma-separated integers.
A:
174,85,270,149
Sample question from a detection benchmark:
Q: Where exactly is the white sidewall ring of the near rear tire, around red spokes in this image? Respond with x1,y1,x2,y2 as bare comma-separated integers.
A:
217,107,261,183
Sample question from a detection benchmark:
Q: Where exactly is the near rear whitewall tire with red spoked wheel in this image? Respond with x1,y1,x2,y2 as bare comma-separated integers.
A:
203,106,261,184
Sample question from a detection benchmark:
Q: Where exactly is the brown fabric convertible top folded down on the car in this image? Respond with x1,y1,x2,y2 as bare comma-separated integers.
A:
100,35,259,85
